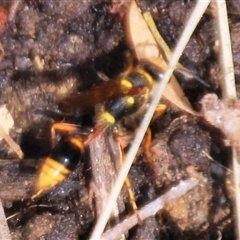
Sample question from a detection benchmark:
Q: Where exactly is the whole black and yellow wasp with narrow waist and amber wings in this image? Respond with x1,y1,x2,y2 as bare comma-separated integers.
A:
32,54,208,198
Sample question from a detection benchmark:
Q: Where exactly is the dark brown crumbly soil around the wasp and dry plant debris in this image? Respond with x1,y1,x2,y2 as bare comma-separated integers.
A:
0,0,237,239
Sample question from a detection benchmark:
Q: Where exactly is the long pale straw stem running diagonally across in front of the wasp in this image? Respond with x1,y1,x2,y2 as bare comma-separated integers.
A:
90,0,210,239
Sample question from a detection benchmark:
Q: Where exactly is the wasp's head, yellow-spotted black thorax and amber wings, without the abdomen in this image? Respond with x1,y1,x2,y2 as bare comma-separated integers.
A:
59,59,162,126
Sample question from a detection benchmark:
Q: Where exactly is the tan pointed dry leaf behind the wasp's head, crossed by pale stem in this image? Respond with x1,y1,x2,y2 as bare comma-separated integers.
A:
126,1,198,115
